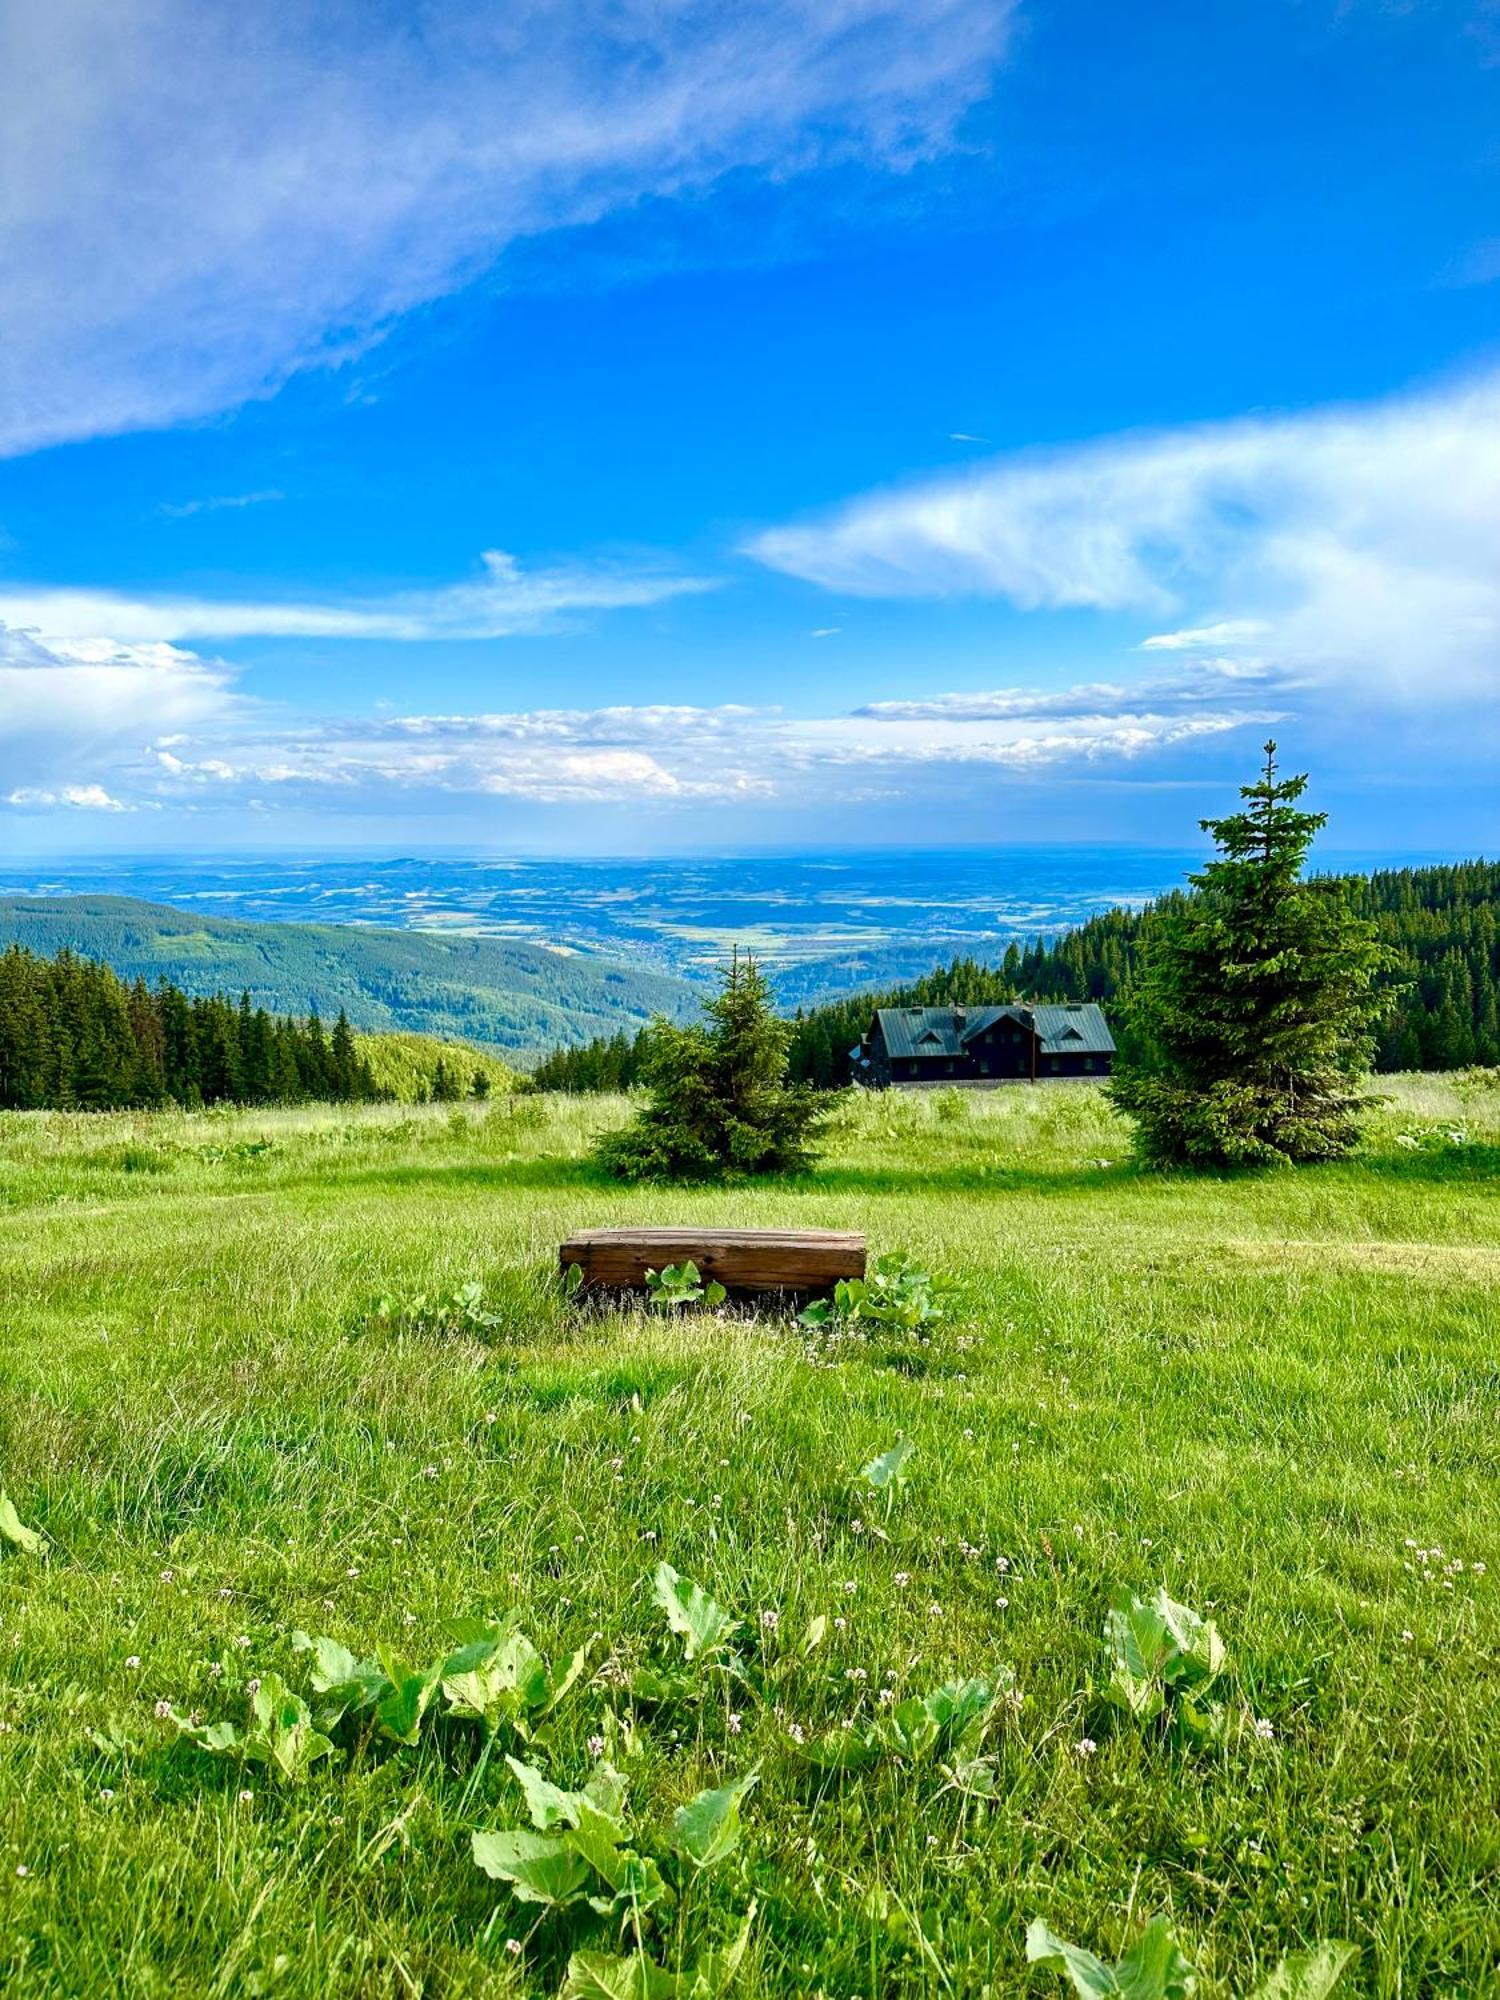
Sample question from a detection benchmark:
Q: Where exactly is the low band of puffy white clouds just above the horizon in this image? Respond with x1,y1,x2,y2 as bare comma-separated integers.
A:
0,628,1280,814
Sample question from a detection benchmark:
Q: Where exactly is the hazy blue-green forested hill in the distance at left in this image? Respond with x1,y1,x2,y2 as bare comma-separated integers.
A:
0,896,698,1056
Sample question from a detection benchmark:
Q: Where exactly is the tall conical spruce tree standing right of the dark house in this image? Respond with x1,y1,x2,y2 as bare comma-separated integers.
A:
1110,742,1394,1168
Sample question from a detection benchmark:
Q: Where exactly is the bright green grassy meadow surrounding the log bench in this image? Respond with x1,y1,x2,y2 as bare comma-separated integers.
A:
0,1080,1500,2000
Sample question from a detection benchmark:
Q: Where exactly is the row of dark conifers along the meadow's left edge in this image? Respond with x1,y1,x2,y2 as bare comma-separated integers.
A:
0,944,388,1110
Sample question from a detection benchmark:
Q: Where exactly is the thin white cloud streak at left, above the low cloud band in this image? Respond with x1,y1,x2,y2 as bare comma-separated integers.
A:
0,548,716,644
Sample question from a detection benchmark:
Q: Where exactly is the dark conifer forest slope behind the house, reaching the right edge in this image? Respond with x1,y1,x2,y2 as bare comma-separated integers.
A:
536,862,1500,1090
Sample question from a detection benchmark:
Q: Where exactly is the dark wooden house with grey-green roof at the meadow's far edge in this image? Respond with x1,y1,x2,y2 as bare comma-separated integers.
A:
850,1002,1114,1088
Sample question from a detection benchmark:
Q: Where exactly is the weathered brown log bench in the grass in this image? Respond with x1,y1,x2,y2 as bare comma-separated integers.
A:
558,1228,864,1292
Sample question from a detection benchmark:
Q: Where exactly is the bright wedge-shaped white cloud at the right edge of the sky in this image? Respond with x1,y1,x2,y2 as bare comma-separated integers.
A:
750,376,1500,702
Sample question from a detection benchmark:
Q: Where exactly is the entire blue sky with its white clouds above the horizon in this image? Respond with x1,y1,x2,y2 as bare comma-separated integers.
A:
0,0,1500,856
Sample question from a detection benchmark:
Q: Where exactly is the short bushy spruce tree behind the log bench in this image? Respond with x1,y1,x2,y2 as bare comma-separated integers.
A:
596,952,820,1180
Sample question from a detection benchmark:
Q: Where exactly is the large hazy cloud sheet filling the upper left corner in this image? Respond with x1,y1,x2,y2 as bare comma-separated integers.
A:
0,0,1012,454
